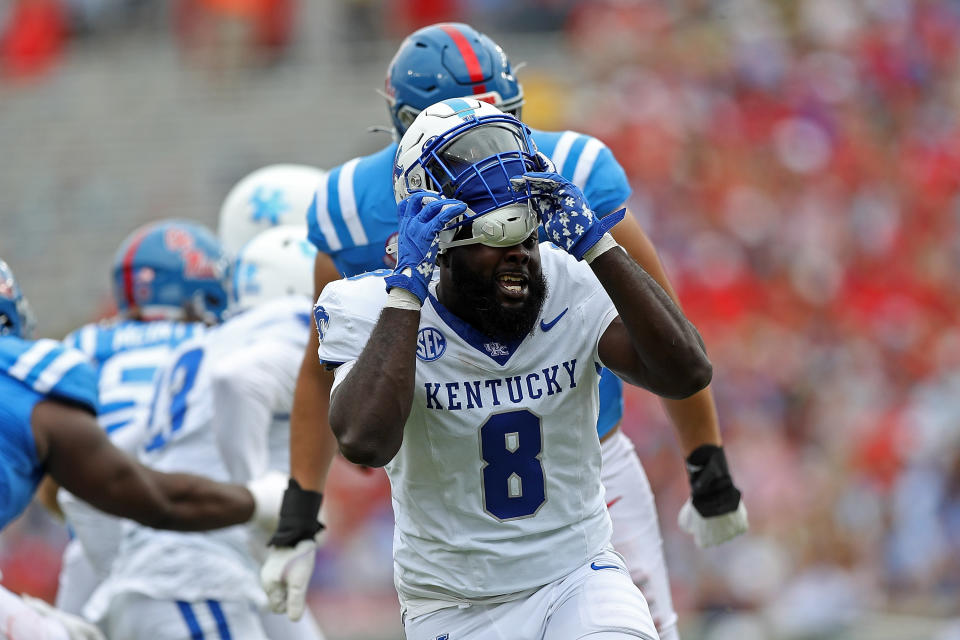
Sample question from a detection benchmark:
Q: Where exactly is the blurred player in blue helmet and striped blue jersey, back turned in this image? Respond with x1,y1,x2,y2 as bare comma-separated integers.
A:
42,220,229,614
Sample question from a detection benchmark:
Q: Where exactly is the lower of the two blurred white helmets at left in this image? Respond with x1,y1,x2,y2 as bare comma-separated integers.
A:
233,225,317,312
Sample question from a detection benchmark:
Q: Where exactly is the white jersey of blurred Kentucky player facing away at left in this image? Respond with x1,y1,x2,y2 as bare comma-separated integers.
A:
86,297,311,619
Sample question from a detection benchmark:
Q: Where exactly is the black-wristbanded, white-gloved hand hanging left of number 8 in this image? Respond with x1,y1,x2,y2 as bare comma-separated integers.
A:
260,478,323,620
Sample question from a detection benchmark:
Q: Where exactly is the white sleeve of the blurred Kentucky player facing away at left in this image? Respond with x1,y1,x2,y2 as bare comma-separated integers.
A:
212,340,303,483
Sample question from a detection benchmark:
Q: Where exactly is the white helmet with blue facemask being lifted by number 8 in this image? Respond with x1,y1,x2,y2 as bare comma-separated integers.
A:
393,98,547,251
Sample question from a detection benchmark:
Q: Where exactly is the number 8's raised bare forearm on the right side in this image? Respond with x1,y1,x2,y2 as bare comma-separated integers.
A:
590,247,712,398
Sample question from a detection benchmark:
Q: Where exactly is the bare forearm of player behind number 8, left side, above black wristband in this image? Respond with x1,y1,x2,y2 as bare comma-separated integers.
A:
290,344,337,492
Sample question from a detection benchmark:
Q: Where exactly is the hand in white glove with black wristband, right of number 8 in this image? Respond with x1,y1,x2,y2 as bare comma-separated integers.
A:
677,445,748,548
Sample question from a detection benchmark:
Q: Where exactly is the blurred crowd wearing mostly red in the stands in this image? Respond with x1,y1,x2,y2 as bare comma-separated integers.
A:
0,0,960,640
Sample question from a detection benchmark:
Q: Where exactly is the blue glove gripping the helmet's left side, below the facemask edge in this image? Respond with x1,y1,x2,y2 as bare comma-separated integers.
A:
385,191,467,304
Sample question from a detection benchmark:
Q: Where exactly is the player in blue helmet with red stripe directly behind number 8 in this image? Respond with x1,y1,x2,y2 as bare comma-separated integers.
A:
262,23,746,640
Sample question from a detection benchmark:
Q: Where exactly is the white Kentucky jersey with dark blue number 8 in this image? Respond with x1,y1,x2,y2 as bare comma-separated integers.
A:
314,243,617,616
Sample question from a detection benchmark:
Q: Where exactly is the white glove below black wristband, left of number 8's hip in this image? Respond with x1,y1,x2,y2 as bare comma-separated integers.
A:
260,532,322,621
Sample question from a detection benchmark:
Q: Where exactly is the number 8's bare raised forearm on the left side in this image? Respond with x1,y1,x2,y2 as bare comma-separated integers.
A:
330,307,420,467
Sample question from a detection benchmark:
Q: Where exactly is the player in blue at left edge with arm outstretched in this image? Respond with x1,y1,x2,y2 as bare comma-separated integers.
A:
0,255,282,640
